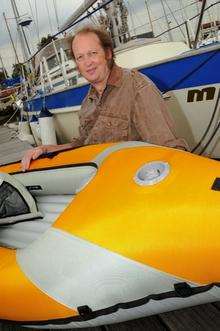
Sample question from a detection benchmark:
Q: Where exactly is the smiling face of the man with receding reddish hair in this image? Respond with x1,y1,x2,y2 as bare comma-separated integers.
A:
72,32,112,85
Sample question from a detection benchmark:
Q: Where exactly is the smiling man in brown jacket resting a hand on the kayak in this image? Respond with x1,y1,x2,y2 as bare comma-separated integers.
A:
22,26,187,171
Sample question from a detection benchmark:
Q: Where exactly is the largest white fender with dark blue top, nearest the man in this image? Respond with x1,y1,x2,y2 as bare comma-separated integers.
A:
39,107,57,145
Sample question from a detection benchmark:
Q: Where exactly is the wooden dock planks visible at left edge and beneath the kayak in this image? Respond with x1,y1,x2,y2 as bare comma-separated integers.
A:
0,127,220,331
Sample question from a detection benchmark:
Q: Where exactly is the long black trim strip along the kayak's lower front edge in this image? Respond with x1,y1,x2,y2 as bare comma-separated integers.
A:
0,282,220,326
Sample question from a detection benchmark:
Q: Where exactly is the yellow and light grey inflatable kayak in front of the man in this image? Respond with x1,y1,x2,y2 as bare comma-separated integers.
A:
0,142,220,328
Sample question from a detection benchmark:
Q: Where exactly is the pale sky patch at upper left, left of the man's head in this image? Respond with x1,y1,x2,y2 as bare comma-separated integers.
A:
0,0,82,70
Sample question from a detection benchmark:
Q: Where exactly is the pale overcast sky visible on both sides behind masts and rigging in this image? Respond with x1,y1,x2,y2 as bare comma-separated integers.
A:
0,0,220,73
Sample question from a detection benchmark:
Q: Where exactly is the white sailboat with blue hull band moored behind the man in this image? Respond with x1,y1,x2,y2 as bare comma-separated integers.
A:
17,1,220,158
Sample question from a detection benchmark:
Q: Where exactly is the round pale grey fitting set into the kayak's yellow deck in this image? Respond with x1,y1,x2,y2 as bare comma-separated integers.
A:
134,161,170,186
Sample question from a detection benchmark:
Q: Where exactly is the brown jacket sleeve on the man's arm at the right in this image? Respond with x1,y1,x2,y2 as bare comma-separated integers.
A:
132,76,188,150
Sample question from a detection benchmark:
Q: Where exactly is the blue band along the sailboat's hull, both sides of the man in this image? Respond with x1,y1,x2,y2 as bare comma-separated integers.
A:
28,47,220,112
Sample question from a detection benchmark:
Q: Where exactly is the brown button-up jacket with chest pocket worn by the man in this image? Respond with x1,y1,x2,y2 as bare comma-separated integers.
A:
74,65,187,149
